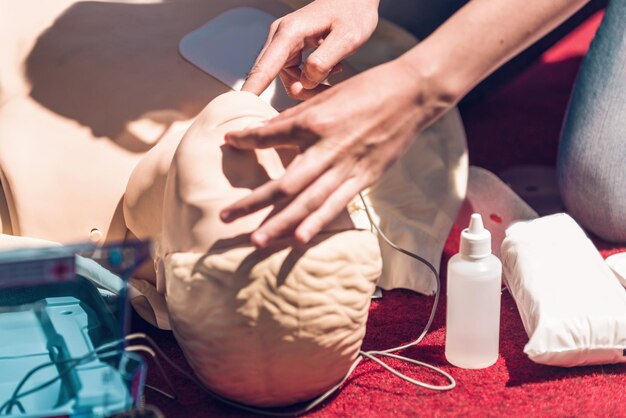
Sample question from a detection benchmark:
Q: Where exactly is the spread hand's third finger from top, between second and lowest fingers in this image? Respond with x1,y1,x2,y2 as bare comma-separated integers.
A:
251,160,349,248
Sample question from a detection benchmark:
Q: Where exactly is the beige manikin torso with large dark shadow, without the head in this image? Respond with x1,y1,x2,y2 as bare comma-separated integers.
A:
0,0,288,242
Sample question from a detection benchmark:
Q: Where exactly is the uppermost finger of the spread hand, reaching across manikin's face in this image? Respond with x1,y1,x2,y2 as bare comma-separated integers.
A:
224,117,317,149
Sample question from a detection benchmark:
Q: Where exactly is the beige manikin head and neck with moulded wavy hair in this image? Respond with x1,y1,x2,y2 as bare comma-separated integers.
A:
124,92,381,406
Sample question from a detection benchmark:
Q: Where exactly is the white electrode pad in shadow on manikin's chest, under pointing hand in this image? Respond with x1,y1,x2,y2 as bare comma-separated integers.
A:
178,7,298,111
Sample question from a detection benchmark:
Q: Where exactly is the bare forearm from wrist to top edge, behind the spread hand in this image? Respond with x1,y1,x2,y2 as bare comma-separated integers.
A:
398,0,587,104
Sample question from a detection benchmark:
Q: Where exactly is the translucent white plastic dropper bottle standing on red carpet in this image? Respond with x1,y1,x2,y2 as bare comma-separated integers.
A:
446,213,502,369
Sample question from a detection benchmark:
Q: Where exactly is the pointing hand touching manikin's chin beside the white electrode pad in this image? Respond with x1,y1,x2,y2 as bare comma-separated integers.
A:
242,0,379,99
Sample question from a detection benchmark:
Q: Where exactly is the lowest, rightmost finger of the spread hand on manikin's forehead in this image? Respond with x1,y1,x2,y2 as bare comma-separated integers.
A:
294,177,363,244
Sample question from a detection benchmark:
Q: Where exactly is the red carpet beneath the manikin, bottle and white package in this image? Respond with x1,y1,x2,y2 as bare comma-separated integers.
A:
134,11,626,418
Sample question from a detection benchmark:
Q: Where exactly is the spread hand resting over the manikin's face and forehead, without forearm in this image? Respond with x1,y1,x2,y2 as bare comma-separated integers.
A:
221,61,452,247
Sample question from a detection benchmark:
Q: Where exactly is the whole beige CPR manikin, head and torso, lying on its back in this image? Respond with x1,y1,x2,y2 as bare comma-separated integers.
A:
0,0,463,405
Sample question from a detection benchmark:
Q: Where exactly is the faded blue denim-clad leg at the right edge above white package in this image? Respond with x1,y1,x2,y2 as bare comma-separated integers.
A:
557,0,626,242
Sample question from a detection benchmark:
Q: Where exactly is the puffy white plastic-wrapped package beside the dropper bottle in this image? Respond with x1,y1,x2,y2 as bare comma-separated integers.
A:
501,214,626,367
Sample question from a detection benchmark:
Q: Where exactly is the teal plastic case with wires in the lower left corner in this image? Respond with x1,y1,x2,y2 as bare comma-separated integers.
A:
0,243,149,417
